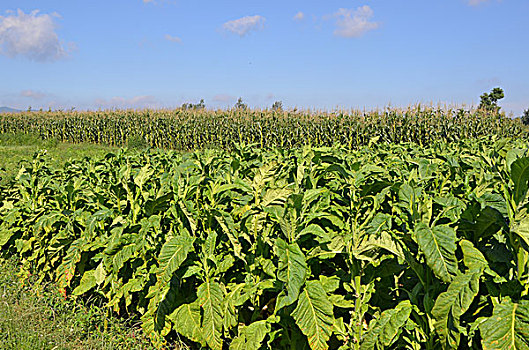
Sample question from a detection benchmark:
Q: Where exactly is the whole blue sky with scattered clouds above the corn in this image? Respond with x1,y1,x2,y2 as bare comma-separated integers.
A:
0,0,529,115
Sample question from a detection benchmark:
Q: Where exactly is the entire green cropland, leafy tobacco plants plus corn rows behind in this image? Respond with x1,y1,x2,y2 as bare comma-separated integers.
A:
0,108,529,350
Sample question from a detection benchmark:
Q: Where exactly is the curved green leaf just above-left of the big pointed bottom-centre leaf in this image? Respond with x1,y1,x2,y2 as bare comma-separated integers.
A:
275,238,307,312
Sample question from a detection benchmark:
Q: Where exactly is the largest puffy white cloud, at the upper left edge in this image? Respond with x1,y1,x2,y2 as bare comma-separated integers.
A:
0,10,67,62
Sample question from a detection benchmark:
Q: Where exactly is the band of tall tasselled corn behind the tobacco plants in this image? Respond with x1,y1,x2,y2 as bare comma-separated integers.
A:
0,107,529,150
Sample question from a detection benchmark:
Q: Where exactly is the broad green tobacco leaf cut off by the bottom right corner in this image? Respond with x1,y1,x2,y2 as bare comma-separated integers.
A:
479,300,529,350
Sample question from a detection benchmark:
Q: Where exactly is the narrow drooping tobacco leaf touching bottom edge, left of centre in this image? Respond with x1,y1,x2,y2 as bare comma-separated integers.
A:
197,281,224,350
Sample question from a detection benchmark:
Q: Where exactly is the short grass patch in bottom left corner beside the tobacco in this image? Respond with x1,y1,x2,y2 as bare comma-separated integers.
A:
0,259,152,350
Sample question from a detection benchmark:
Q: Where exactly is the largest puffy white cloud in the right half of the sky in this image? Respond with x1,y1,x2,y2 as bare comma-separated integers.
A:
334,5,379,38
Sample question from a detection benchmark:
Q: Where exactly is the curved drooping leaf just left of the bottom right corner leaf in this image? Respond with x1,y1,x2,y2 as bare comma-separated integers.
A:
432,272,481,348
